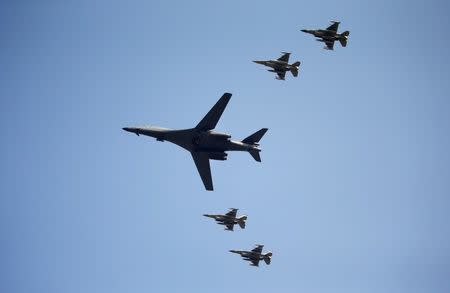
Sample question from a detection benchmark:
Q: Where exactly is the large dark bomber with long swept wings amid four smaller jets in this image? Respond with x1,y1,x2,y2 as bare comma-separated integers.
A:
123,93,267,190
